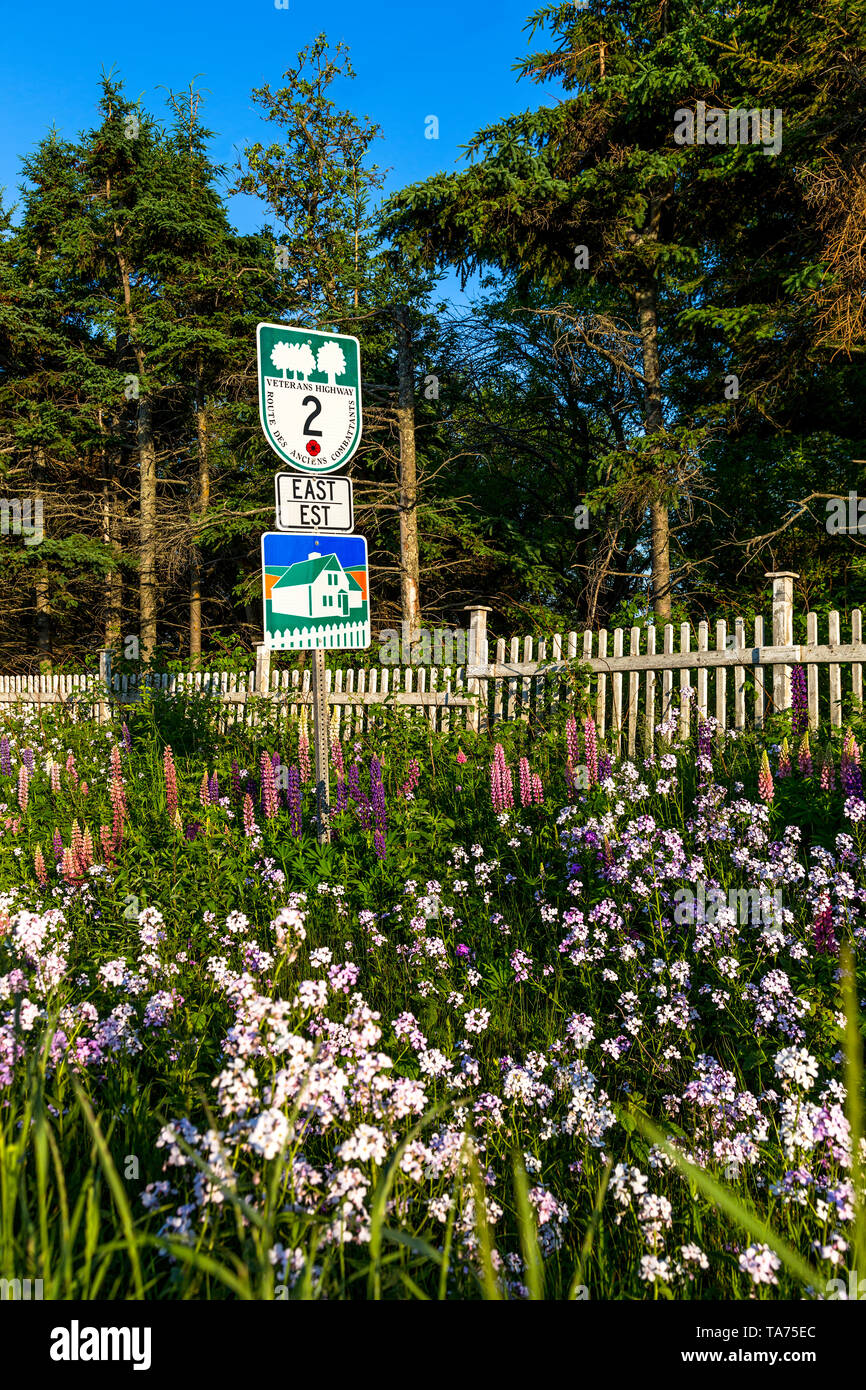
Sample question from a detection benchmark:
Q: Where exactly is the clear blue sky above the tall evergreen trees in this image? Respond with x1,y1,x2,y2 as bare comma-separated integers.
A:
0,0,557,309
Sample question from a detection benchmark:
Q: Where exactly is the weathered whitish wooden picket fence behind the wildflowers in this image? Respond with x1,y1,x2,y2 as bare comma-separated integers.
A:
0,571,866,755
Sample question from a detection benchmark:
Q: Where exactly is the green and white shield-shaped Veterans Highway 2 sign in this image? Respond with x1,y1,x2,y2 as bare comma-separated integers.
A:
256,324,361,474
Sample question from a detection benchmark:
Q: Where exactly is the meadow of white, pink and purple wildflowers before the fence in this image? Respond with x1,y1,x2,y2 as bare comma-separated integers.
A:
0,669,866,1301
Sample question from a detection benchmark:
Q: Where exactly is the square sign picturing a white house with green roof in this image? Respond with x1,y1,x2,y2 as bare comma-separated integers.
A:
261,531,370,652
